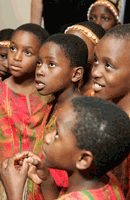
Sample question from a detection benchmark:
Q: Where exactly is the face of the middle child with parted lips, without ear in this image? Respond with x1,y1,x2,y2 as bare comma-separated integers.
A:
35,42,73,95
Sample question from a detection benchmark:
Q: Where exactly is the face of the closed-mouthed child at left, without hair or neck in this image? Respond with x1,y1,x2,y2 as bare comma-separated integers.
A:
8,31,40,77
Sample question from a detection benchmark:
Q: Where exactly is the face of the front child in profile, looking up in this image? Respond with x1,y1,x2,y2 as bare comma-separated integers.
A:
43,103,80,170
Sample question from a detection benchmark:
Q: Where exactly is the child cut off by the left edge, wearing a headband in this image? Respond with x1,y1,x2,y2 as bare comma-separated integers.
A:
0,28,14,82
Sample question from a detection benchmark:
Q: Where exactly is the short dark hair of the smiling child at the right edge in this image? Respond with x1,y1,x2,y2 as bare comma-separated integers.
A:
105,24,130,41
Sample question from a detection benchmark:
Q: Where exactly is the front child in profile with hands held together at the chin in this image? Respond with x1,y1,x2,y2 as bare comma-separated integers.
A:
1,96,130,200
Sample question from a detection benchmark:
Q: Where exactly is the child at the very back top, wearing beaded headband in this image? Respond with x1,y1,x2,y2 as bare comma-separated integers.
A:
87,0,120,31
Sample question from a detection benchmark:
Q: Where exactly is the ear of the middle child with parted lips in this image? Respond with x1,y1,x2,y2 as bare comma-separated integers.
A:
72,66,84,83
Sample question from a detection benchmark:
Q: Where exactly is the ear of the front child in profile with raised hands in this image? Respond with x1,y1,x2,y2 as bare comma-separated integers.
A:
76,151,93,170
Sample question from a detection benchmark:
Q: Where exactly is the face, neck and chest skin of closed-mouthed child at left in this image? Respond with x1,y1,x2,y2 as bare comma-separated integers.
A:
5,31,41,116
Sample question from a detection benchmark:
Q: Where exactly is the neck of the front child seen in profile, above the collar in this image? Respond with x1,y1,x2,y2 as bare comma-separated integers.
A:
66,171,109,193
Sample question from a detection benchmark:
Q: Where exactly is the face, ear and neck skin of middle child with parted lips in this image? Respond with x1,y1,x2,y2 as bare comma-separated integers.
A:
35,42,84,121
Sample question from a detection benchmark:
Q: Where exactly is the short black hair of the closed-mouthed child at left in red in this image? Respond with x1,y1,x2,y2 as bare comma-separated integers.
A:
12,23,50,44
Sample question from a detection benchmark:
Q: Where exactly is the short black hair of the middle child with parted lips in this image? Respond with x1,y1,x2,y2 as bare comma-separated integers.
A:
43,33,88,69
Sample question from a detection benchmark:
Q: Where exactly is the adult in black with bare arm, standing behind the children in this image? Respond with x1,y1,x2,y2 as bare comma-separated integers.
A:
31,0,94,35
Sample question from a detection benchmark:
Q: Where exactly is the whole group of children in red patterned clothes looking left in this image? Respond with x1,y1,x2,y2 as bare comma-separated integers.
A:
0,0,130,200
